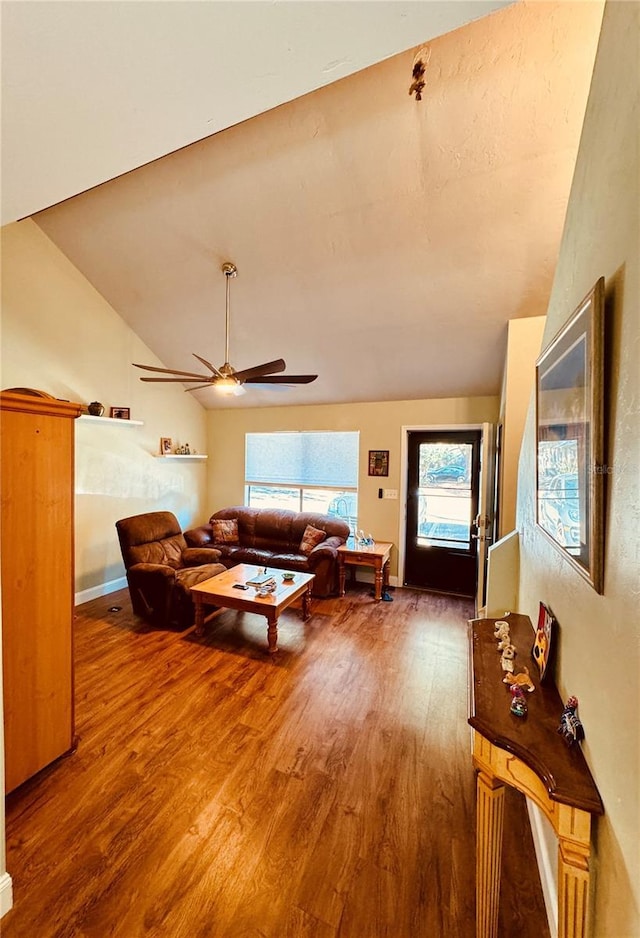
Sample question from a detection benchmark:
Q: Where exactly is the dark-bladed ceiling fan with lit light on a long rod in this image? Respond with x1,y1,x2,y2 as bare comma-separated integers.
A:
133,261,318,394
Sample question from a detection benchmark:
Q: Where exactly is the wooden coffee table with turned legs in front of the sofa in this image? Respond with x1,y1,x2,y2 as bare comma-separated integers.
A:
191,563,315,655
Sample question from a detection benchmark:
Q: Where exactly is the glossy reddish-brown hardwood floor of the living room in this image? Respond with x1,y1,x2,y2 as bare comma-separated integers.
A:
0,587,549,938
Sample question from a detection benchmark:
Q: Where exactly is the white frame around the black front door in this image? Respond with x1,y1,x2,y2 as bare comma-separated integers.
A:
398,421,495,603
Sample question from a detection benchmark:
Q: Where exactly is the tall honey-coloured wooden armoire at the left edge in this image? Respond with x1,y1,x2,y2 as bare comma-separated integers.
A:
0,391,80,792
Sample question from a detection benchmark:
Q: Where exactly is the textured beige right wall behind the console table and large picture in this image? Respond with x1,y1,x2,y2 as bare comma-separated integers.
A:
518,2,640,938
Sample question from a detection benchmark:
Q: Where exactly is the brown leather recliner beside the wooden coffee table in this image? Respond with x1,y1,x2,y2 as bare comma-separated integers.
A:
116,511,226,628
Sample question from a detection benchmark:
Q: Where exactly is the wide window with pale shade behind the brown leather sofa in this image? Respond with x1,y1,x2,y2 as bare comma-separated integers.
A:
245,431,360,531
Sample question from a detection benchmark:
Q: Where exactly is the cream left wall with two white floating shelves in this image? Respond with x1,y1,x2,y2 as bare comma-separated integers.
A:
0,220,207,592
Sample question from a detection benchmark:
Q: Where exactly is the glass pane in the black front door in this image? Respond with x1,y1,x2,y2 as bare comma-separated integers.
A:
417,443,473,550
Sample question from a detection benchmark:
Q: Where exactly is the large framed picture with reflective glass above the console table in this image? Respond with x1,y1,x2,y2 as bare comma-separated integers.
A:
536,277,609,593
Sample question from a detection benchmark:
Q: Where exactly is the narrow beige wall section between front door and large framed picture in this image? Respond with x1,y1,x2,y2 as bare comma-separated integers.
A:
500,316,545,537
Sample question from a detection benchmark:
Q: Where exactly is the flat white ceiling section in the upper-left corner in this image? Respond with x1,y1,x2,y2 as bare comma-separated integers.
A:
0,0,511,224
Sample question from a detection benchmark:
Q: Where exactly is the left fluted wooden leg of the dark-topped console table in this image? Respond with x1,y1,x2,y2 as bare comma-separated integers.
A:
476,770,504,938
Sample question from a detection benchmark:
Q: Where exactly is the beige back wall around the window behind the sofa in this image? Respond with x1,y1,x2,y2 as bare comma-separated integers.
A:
209,397,498,576
